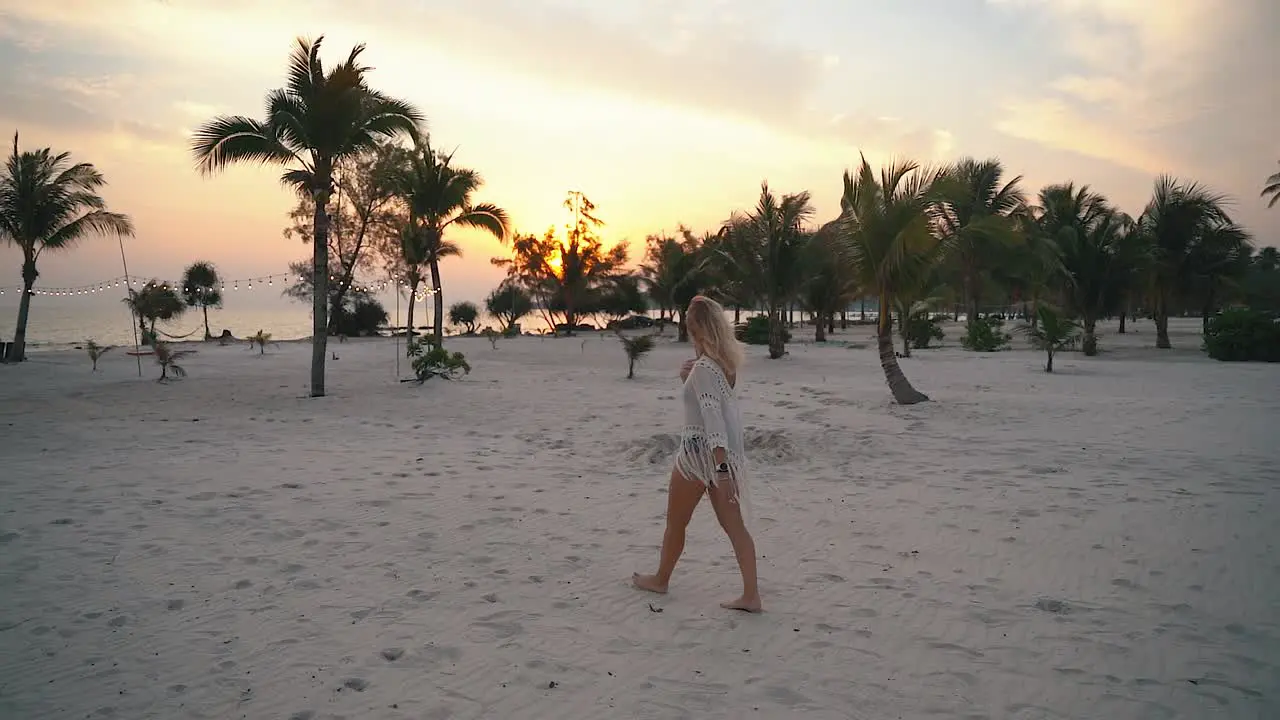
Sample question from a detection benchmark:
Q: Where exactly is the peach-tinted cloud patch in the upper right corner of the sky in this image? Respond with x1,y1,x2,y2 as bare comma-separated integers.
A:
987,0,1274,173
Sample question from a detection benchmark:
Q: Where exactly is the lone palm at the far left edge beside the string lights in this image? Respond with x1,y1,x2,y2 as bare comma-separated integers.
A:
0,133,133,363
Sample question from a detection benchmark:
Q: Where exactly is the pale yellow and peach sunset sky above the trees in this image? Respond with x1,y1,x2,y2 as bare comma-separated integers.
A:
0,0,1280,302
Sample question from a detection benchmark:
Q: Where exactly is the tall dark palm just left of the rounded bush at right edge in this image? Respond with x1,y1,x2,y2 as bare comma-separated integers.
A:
1138,176,1231,350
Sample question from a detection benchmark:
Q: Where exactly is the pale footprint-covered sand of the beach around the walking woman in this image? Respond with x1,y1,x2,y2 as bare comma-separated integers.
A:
0,322,1280,720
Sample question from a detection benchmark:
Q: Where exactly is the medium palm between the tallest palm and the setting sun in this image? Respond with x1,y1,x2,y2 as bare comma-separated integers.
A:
394,138,511,347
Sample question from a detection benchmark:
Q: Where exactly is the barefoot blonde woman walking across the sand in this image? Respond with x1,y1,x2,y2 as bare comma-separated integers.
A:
631,295,762,612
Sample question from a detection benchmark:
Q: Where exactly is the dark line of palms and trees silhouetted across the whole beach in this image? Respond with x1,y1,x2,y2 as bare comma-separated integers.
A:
0,33,1280,402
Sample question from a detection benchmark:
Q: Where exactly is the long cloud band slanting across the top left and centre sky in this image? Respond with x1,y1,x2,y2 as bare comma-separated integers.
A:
0,0,952,159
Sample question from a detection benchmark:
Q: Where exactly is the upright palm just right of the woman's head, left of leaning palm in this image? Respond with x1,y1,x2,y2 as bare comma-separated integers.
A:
721,182,813,360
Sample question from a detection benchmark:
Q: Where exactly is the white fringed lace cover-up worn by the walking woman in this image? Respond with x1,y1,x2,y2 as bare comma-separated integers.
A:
676,357,750,519
